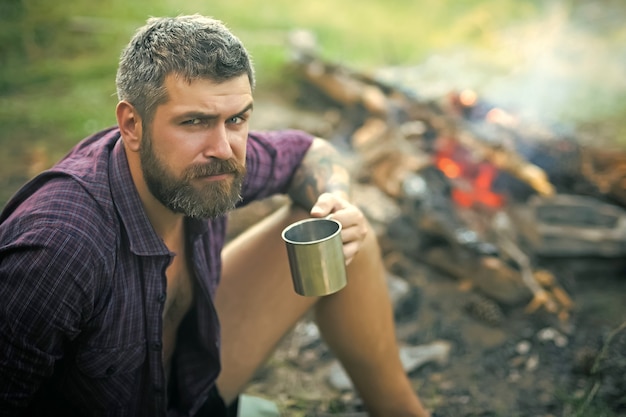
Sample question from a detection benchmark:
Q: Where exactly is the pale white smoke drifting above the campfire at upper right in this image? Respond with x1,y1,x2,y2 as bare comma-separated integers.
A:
379,0,626,124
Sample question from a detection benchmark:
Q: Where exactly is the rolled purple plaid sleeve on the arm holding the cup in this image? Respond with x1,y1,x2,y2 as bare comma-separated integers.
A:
236,130,313,205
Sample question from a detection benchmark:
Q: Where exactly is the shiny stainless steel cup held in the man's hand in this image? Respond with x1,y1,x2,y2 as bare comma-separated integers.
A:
282,218,347,296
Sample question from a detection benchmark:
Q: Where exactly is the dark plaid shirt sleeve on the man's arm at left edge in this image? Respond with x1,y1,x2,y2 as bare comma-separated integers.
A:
0,181,101,415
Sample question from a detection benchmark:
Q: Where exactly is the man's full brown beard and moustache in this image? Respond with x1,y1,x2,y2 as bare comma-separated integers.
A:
139,132,246,219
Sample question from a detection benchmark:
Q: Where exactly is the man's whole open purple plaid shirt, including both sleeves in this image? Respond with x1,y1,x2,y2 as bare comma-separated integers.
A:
0,128,312,417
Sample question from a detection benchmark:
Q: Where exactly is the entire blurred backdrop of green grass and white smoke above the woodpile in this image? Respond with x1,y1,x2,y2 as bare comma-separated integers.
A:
0,0,626,207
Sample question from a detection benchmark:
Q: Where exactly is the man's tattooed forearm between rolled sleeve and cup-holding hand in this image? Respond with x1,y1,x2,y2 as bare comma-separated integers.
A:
288,138,350,210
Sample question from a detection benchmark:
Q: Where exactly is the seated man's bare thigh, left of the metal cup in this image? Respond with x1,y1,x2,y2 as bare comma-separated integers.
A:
215,207,317,402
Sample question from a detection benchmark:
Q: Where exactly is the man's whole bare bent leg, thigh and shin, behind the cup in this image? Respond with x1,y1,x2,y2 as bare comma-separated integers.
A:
215,208,428,417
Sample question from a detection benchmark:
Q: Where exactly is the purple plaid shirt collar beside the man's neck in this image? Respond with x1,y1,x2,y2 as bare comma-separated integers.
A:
109,138,170,256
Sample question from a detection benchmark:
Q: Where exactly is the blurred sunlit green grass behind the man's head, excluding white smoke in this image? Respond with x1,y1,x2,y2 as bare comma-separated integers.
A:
0,0,537,128
